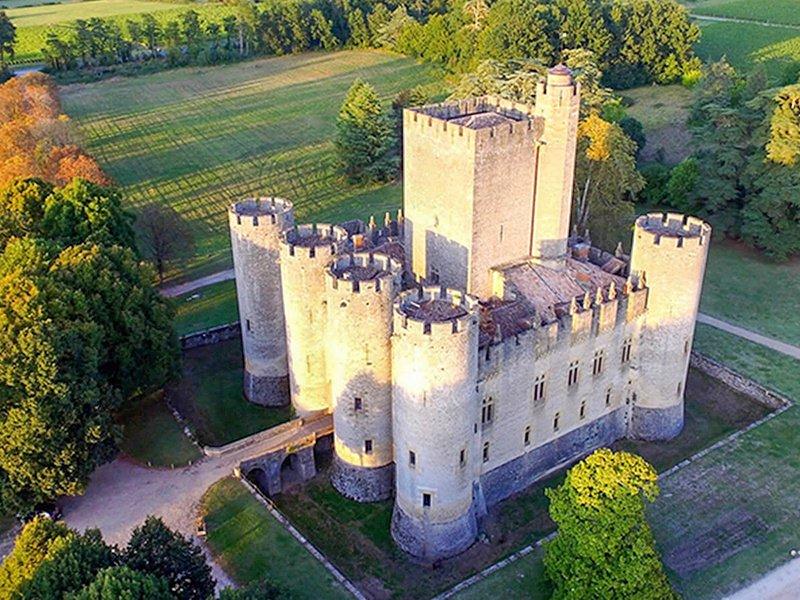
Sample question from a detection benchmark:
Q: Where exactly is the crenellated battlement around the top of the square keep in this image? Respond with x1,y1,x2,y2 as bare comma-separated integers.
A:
403,96,544,149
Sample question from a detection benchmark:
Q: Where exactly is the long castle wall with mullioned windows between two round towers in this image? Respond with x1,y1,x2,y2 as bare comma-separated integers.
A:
476,290,647,504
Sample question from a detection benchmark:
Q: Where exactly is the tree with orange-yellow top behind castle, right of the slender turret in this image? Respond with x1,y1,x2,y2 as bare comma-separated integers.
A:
573,114,645,248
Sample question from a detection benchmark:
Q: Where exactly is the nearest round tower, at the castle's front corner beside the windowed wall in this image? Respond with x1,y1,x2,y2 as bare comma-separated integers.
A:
391,287,480,559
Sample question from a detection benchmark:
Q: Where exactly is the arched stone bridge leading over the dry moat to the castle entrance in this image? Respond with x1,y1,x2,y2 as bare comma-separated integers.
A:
228,413,333,496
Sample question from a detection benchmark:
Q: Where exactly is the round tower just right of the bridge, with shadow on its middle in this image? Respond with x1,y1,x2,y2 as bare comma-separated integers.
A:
326,252,402,502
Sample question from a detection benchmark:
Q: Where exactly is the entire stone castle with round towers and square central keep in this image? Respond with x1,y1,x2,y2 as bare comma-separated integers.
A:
229,66,711,559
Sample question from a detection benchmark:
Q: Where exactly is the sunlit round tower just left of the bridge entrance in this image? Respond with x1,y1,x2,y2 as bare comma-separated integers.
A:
280,225,347,417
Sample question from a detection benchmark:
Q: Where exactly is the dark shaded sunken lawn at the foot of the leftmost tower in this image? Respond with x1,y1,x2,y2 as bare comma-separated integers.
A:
167,338,291,446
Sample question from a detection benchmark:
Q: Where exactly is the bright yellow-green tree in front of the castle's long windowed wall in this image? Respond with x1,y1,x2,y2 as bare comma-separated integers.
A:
544,448,677,600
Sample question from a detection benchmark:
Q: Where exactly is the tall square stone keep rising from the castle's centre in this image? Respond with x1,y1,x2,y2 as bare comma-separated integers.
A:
403,96,544,296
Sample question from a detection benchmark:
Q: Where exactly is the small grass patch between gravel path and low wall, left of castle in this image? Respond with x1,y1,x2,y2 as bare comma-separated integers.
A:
175,281,239,335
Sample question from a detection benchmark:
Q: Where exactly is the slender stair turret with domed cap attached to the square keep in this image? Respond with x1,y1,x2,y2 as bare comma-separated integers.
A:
530,65,581,269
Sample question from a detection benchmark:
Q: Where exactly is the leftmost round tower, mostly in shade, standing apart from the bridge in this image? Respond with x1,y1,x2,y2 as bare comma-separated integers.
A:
228,198,294,406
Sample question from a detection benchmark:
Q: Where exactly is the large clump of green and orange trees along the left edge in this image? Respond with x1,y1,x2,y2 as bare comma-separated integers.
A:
0,73,179,512
